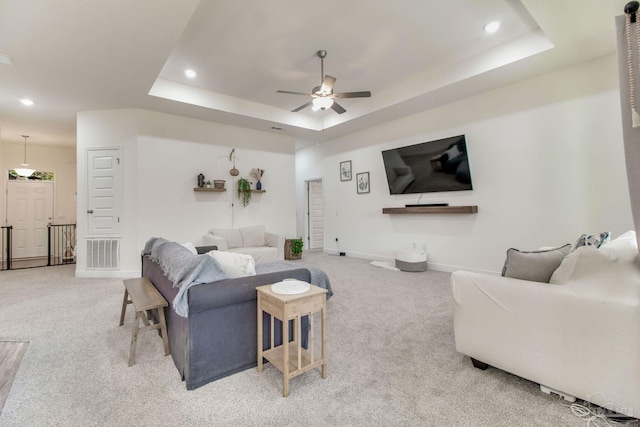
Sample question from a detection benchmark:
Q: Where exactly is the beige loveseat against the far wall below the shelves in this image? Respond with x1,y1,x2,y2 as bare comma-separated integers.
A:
202,225,284,264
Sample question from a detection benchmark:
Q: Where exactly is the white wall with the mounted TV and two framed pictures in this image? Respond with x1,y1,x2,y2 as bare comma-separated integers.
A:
296,56,633,272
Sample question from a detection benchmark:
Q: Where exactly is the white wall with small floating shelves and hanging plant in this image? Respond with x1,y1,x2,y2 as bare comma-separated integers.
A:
76,110,296,276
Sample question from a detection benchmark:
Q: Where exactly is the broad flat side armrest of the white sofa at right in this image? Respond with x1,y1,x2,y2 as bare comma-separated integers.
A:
451,271,640,412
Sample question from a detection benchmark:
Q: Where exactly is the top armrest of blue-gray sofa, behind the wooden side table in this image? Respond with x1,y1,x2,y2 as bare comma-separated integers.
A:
188,268,311,316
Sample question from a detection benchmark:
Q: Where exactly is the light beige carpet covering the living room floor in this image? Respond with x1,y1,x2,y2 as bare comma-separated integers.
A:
0,252,584,426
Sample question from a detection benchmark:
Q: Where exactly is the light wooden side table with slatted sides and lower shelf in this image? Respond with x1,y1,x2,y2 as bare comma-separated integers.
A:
256,285,327,397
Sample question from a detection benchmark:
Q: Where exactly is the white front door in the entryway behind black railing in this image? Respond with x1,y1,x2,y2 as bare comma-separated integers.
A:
7,180,53,258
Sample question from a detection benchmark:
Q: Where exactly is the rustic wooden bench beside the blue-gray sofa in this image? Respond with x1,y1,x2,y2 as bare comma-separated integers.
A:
120,277,170,366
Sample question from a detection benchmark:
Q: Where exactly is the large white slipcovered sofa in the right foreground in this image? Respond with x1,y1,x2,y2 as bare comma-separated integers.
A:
451,231,640,417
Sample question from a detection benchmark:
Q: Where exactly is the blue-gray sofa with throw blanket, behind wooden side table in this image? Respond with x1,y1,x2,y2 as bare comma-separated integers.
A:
142,242,312,390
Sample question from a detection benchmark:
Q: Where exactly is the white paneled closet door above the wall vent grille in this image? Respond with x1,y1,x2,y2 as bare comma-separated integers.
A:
87,148,122,236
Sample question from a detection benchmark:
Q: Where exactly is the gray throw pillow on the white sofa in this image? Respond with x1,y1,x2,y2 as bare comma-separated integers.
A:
502,243,571,283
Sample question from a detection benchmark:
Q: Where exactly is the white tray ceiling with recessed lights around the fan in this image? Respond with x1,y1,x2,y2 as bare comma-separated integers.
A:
0,0,627,150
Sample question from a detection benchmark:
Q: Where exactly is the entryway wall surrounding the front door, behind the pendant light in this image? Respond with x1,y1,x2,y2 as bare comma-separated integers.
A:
0,141,76,225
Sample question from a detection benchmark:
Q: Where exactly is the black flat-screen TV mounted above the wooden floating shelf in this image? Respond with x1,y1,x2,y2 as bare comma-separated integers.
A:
382,135,473,194
